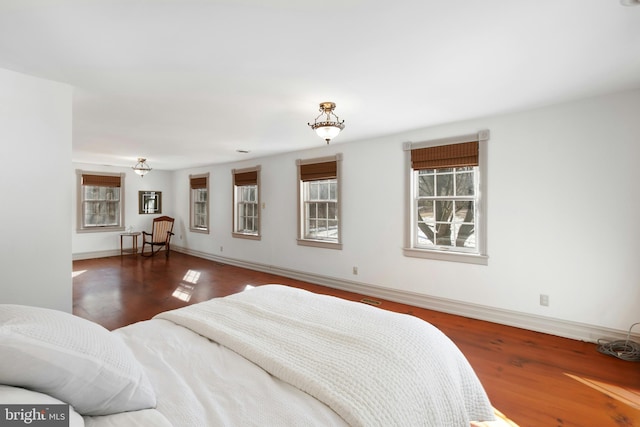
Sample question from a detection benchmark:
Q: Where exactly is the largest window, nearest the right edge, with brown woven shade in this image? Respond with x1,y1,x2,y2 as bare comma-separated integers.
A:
404,131,489,264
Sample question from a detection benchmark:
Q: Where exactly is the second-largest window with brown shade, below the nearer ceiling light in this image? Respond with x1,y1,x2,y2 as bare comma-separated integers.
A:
297,154,342,249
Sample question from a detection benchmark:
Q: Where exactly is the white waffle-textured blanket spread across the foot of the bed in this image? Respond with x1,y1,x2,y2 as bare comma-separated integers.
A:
154,285,493,427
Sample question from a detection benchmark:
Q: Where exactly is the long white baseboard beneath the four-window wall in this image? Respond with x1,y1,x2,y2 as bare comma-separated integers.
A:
171,245,640,343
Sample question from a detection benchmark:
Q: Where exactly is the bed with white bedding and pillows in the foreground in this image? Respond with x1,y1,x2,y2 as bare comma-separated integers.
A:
0,285,494,427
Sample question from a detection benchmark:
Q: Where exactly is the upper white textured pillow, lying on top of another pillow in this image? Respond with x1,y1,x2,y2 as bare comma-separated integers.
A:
0,304,156,415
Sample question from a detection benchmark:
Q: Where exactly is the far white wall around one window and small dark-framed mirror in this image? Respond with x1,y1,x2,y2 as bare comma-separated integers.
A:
72,164,175,259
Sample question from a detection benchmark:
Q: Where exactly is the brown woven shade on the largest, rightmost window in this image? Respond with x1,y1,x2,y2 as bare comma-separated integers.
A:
411,141,478,169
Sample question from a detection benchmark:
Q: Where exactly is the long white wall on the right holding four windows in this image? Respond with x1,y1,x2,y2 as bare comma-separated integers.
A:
174,91,640,331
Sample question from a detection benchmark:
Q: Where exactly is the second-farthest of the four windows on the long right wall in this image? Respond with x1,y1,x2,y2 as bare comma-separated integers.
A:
231,166,260,240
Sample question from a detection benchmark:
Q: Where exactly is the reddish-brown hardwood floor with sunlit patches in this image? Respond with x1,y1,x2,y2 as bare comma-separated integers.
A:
73,252,640,427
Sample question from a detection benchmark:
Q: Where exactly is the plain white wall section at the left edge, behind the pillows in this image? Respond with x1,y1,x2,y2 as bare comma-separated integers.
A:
0,69,72,312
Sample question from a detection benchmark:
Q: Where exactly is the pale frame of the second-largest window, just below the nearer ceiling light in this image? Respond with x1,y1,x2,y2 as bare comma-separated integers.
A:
296,153,343,250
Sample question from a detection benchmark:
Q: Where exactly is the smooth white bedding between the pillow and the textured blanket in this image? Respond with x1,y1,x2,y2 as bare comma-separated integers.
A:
110,319,347,427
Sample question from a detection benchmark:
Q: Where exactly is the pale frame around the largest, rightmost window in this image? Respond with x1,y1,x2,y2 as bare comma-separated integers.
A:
403,130,490,265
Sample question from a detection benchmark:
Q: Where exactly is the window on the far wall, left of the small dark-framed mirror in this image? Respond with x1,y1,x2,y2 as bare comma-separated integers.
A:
76,170,124,232
